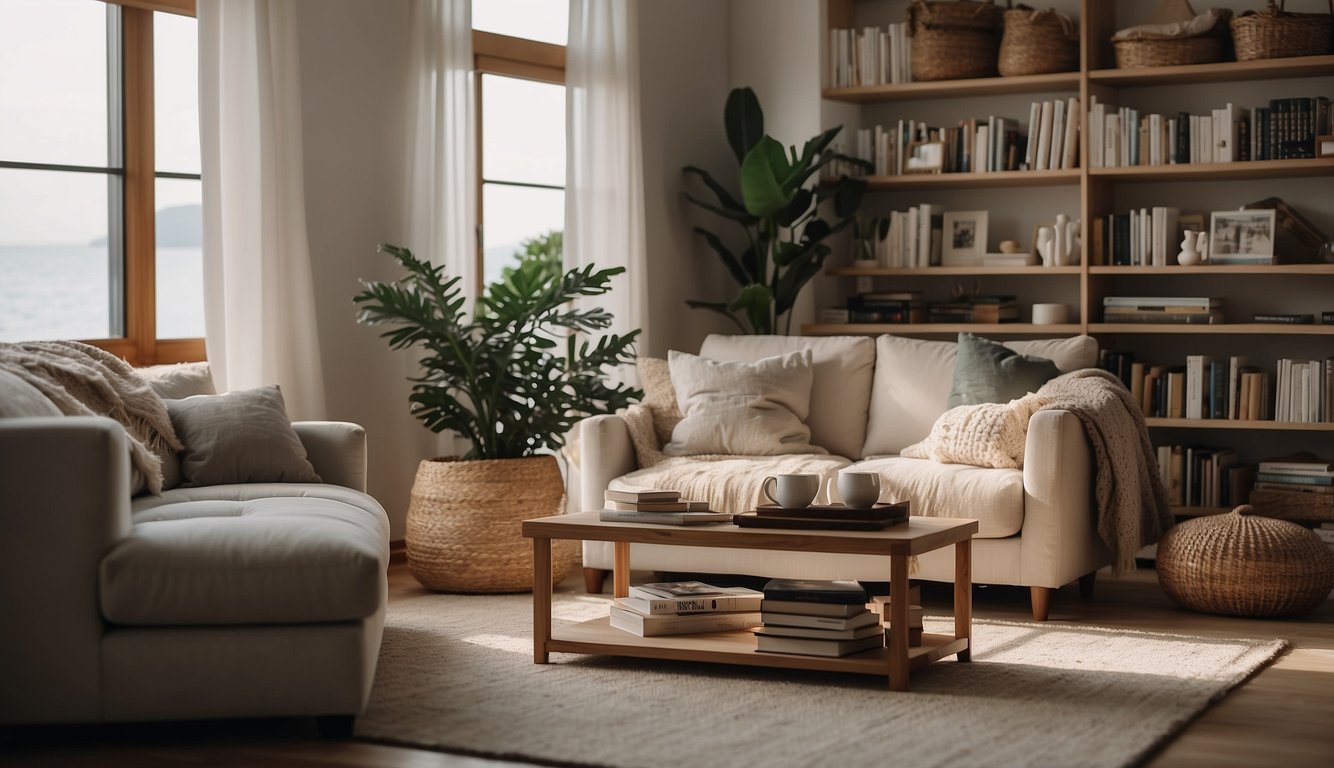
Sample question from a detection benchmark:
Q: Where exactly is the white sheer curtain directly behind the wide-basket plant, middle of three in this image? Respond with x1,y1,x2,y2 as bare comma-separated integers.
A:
404,0,478,312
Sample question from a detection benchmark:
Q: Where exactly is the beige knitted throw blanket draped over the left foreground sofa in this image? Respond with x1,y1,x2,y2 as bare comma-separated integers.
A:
0,341,183,495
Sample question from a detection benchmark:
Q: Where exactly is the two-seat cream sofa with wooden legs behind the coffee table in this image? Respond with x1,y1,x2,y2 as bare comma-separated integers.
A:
579,335,1110,620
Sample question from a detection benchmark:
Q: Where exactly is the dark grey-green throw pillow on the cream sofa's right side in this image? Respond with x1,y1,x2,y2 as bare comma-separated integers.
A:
948,333,1061,408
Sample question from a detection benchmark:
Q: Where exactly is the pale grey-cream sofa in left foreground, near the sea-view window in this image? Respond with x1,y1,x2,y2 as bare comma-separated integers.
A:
0,371,390,733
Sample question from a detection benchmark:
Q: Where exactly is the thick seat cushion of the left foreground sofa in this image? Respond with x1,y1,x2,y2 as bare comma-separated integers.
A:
100,485,390,625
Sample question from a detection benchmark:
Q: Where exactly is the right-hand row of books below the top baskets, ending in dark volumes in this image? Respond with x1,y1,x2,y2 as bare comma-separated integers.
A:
1089,96,1331,168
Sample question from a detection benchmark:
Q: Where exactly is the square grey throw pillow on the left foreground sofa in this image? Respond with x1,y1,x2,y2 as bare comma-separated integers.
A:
167,385,321,488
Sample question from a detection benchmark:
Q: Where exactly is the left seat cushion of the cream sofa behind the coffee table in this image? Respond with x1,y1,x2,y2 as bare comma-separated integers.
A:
607,453,848,515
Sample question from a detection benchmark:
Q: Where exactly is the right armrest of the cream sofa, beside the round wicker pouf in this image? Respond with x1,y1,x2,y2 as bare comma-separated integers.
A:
1022,409,1110,587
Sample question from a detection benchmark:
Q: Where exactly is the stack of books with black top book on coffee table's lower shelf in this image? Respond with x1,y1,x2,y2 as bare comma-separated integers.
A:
755,579,884,656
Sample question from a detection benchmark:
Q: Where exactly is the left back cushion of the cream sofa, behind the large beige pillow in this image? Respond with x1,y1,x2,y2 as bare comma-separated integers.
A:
699,333,875,457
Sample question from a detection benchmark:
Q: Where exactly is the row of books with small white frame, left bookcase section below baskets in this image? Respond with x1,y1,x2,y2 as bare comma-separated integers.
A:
856,96,1079,176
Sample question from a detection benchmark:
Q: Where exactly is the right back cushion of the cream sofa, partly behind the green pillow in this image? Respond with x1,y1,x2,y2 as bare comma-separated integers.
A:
862,335,1098,456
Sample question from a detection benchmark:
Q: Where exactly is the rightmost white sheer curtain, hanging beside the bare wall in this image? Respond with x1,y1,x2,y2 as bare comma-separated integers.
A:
564,0,648,349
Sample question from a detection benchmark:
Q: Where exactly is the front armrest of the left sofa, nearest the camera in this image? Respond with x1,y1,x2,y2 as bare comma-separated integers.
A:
0,416,129,724
